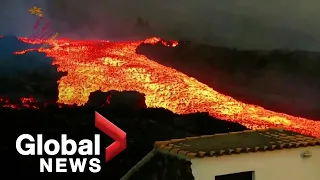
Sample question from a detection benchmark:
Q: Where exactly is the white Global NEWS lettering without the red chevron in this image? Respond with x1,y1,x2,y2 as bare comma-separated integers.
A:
16,134,101,173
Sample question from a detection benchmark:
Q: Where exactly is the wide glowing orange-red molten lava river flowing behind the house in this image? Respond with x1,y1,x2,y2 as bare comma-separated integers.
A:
16,38,320,137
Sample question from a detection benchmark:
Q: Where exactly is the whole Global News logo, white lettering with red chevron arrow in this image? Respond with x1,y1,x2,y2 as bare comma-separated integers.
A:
16,112,126,173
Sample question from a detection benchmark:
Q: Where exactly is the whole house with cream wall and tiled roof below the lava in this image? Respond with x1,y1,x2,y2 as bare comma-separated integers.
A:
121,129,320,180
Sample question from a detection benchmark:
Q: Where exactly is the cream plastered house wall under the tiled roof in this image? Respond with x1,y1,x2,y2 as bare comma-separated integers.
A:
191,146,320,180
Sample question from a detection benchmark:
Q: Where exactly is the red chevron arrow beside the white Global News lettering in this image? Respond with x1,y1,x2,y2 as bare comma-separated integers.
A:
95,112,127,162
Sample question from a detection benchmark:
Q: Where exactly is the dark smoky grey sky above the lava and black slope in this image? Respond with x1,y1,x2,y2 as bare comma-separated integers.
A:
0,0,320,51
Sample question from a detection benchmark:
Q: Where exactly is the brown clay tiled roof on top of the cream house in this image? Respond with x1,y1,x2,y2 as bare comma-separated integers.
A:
154,129,320,158
